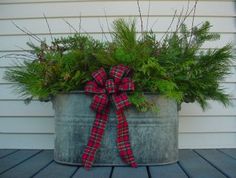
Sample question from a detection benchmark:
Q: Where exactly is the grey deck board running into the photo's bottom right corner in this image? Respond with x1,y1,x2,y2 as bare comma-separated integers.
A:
196,150,236,178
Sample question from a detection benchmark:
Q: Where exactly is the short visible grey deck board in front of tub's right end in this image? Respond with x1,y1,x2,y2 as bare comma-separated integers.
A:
149,163,188,178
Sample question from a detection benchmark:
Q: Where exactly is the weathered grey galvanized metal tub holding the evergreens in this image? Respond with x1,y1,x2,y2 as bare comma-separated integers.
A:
53,92,178,165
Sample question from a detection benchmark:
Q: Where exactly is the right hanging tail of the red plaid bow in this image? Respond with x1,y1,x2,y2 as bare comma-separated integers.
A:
116,109,137,167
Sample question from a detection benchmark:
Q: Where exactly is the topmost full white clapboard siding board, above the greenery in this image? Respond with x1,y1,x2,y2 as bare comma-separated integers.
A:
0,0,235,19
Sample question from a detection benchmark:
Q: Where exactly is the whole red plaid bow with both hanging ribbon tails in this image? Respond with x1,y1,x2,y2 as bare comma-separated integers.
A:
82,65,137,169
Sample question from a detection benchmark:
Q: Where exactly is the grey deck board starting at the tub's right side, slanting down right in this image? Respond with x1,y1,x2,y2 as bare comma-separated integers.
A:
179,150,225,178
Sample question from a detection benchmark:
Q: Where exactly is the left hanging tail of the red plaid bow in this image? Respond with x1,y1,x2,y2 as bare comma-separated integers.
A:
82,107,109,170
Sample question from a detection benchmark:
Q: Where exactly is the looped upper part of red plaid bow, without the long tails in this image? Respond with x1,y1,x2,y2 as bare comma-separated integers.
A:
85,65,134,112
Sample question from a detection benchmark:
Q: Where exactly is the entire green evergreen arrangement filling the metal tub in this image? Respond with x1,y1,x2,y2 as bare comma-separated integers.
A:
5,19,232,111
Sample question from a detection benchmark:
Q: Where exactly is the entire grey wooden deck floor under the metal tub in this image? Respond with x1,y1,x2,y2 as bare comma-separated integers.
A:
0,149,236,178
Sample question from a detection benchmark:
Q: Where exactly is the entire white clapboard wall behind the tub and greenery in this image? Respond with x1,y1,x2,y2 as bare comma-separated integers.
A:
0,0,236,148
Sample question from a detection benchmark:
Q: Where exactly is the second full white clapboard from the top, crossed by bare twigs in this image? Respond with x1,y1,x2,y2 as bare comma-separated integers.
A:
0,16,235,36
